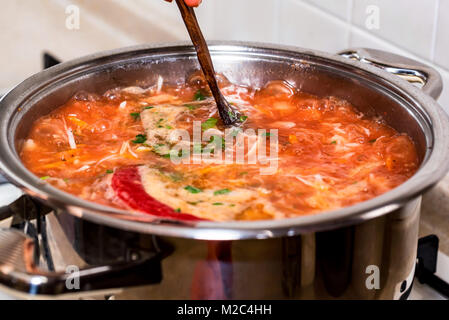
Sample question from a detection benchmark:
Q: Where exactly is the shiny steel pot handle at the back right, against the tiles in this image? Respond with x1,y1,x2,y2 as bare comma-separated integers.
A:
339,48,443,100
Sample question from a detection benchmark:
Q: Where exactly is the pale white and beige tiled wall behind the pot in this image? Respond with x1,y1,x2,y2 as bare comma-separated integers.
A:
0,0,449,112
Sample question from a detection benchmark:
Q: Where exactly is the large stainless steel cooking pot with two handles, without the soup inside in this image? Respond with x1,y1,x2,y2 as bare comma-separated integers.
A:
0,42,449,299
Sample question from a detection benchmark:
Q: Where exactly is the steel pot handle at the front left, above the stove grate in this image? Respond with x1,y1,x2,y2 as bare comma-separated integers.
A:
0,229,162,298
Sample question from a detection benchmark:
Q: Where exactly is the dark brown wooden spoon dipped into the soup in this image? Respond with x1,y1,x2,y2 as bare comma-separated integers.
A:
176,0,241,126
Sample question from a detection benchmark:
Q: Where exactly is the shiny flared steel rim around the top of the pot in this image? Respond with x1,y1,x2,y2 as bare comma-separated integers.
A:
0,41,449,240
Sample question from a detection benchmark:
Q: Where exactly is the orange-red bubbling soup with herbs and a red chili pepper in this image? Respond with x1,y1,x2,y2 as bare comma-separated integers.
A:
21,79,419,221
